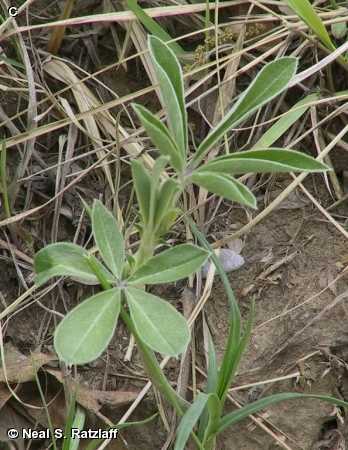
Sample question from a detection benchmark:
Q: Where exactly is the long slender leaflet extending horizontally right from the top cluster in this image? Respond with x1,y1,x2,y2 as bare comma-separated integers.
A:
195,148,330,175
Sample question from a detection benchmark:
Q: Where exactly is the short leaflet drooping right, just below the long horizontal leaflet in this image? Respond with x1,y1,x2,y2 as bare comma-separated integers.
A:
191,171,256,209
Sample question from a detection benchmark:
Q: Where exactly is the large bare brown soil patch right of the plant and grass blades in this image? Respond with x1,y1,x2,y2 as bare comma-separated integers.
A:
206,177,348,450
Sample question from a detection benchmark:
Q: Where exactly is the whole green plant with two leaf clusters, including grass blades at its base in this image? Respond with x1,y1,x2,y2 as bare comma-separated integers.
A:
35,36,342,450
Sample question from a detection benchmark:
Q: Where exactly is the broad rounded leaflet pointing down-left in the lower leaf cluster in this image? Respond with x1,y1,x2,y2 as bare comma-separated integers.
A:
54,288,121,364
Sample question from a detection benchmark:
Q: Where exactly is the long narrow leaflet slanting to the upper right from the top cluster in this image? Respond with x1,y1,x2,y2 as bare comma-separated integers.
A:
193,57,298,167
